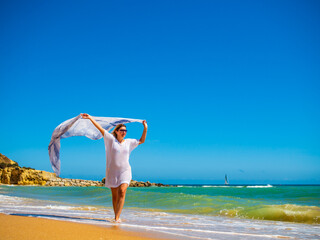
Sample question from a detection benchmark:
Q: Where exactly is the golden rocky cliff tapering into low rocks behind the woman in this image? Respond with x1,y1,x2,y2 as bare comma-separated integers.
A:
0,153,168,187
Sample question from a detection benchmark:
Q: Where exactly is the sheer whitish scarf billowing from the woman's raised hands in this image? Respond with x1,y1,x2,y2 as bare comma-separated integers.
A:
48,115,142,176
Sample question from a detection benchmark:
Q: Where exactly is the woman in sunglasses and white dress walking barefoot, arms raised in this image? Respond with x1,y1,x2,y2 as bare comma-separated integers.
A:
81,113,148,223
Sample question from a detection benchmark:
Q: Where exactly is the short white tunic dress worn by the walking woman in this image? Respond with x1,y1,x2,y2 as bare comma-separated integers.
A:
103,131,139,188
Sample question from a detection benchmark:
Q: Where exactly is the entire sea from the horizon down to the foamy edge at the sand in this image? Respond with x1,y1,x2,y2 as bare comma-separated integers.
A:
0,185,320,239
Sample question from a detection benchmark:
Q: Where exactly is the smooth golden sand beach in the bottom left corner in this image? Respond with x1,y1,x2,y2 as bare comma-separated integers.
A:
0,214,172,240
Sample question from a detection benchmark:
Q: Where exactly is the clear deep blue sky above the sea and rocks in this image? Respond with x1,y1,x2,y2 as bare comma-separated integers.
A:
0,0,320,183
